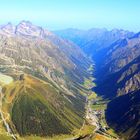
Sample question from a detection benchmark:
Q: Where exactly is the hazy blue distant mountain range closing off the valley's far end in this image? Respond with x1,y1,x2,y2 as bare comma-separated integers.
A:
55,28,134,57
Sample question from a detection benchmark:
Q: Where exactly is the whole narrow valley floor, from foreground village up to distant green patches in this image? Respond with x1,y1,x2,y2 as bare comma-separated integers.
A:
63,66,120,140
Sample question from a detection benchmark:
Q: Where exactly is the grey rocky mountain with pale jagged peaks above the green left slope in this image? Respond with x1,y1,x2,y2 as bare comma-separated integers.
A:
0,21,89,88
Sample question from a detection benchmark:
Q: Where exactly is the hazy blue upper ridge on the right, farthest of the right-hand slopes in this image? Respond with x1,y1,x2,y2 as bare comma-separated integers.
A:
96,35,140,79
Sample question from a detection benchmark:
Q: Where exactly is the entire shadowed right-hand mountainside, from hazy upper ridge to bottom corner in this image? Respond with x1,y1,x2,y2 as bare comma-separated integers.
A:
100,34,140,139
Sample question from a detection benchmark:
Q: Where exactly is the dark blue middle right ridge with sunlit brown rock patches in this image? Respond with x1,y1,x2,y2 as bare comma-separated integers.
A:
94,56,140,98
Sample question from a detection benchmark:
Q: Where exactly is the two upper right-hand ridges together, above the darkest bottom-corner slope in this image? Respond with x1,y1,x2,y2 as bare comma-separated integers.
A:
95,33,140,98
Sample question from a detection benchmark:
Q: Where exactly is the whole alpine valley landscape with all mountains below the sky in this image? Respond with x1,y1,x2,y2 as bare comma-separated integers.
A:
0,21,140,140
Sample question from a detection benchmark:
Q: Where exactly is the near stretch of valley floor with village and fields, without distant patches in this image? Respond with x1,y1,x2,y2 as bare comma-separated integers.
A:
71,93,119,140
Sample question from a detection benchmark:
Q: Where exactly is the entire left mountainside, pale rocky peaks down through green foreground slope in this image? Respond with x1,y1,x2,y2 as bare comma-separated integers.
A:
0,21,91,136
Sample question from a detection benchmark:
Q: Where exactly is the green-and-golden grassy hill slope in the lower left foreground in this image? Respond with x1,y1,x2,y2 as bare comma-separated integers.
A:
3,75,84,136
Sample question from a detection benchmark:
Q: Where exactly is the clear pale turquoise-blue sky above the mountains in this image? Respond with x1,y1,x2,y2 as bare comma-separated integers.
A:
0,0,140,31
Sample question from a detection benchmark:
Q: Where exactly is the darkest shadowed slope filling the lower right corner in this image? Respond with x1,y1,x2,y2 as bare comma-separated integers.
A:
106,90,140,140
